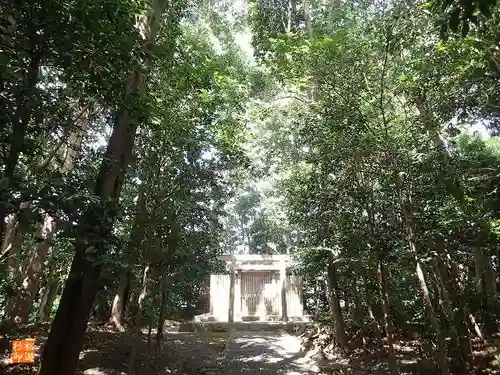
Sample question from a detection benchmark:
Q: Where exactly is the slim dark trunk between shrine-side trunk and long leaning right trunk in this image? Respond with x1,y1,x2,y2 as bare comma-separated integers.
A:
377,255,398,375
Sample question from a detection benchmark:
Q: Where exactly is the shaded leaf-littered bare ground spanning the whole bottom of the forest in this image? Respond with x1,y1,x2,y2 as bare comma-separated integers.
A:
0,327,500,375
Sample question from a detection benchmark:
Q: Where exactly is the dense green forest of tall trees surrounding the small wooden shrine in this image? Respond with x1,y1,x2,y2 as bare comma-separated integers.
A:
0,0,500,375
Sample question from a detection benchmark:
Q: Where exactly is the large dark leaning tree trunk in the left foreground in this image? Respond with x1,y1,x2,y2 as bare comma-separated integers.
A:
39,0,167,375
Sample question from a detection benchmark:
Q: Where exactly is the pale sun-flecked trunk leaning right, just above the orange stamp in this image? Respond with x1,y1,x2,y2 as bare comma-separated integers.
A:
10,215,55,324
